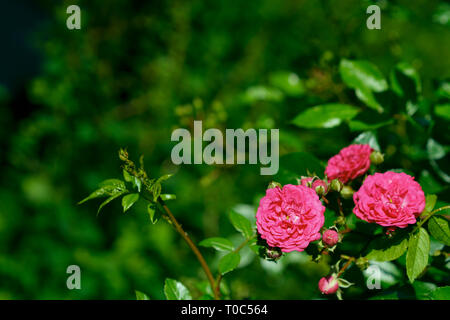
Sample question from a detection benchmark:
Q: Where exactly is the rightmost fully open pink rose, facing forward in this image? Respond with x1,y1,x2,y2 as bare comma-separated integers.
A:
353,171,425,228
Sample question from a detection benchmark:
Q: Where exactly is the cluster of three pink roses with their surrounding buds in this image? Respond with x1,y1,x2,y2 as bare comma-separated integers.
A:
256,144,425,298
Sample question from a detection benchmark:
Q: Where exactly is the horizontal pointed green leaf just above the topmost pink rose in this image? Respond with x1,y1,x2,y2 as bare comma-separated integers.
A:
292,103,359,128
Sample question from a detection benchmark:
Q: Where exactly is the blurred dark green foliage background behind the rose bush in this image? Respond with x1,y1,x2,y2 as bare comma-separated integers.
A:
0,0,450,299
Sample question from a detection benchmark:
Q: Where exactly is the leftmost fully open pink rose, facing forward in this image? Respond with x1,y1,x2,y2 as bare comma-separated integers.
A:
256,184,325,252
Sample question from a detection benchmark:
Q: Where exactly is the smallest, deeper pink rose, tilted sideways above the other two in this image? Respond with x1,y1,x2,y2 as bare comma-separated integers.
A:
325,144,373,183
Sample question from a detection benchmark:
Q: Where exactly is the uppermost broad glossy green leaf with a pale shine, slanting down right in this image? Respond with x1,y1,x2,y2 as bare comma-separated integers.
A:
339,59,388,92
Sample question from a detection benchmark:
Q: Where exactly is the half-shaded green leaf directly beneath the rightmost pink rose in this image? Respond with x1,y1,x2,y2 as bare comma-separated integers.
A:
366,230,408,261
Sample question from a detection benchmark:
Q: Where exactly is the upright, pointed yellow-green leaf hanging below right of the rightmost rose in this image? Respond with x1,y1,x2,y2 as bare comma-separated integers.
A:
406,228,430,283
